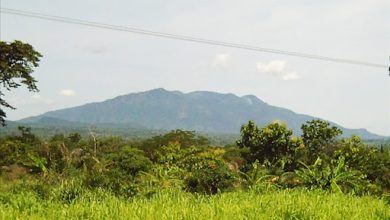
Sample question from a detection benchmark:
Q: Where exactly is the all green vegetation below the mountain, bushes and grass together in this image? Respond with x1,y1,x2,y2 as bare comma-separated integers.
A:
0,120,390,219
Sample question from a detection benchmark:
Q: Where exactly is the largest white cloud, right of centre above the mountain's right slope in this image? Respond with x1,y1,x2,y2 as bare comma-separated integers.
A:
257,60,301,80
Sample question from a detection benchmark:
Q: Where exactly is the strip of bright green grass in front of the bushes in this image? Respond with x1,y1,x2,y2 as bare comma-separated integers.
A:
0,185,390,220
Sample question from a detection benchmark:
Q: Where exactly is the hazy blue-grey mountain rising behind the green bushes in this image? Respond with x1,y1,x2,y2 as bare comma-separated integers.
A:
19,88,383,139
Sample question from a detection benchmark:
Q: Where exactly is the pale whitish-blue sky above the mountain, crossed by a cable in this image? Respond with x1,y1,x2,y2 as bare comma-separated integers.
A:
0,0,390,135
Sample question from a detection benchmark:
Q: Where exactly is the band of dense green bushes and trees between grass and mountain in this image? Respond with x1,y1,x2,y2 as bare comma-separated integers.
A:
0,120,390,198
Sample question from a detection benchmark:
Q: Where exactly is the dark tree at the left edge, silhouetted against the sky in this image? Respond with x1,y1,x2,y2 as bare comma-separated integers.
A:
0,41,42,126
